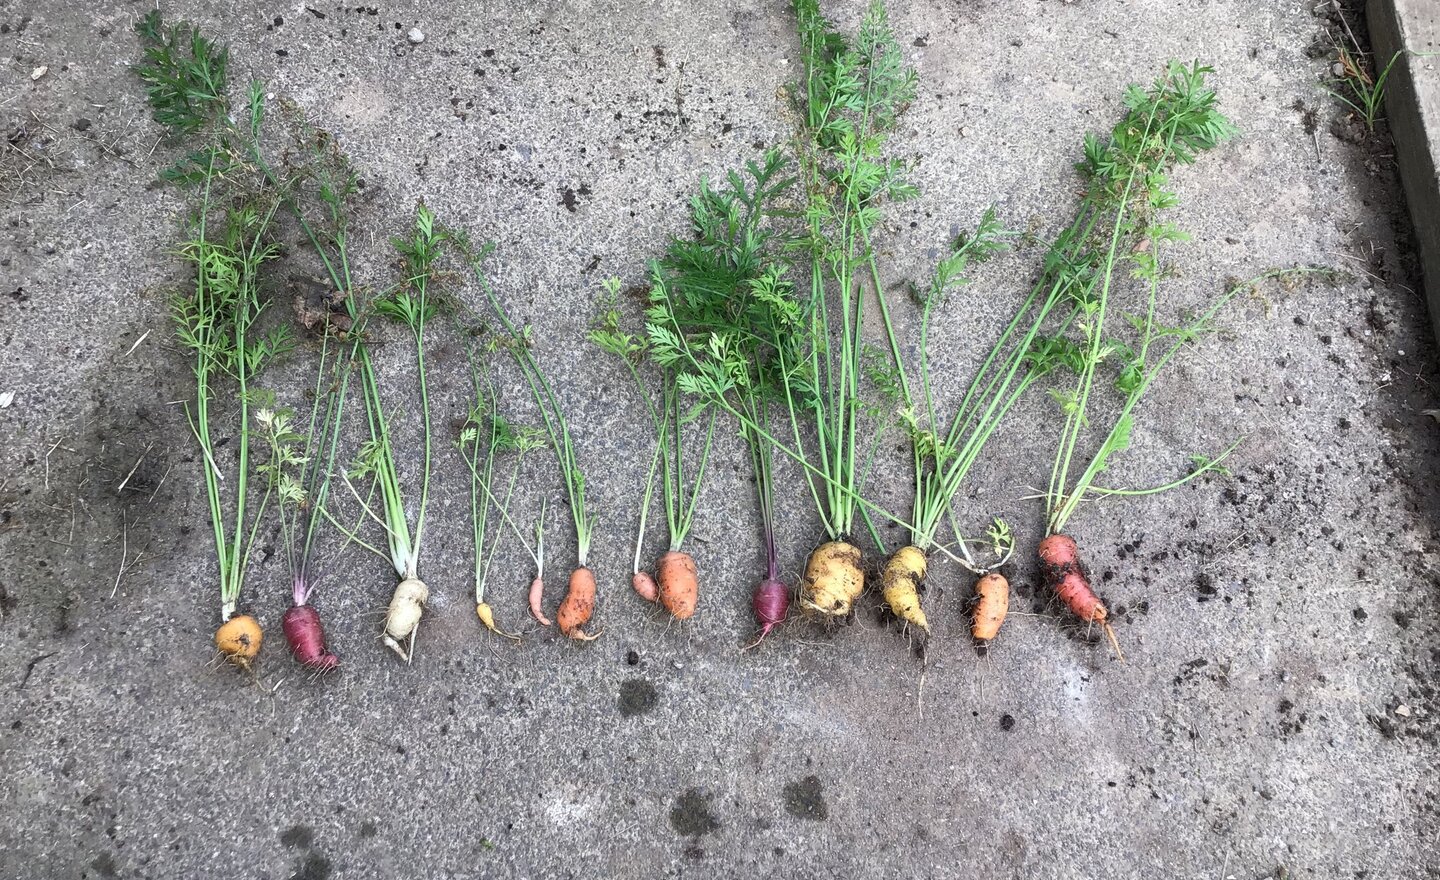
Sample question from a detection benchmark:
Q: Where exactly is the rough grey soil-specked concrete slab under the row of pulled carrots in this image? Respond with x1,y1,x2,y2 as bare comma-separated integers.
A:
0,0,1440,880
